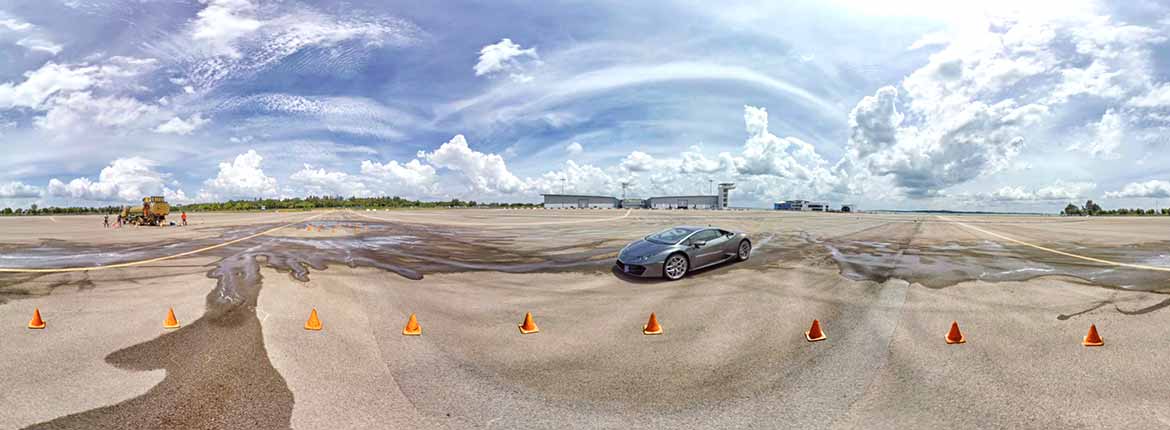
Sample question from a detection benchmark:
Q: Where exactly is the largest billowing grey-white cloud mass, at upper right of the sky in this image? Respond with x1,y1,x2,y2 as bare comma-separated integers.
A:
840,14,1166,197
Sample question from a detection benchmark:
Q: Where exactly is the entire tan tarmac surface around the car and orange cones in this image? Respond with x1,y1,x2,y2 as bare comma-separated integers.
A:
0,209,1170,429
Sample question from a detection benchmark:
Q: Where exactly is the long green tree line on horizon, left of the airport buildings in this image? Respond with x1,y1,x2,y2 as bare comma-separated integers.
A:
0,196,541,215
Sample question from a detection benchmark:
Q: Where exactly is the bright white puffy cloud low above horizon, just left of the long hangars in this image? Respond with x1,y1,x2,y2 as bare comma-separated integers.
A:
419,134,524,194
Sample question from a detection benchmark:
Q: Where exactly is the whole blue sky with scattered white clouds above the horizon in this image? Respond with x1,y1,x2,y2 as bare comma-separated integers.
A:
0,0,1170,211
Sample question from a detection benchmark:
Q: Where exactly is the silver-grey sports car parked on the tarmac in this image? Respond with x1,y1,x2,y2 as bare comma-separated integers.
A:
617,227,751,280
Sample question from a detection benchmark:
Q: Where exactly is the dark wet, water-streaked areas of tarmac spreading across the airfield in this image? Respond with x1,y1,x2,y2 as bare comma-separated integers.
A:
0,210,1170,429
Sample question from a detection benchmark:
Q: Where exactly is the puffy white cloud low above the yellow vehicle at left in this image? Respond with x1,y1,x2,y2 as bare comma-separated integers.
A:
48,157,185,202
